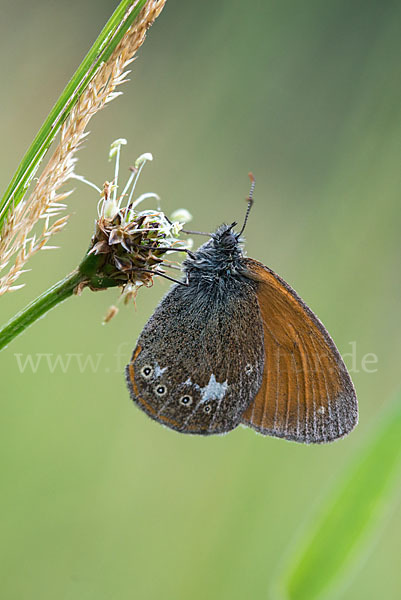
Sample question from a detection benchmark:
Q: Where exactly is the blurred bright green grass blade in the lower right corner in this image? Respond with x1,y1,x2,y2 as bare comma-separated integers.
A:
280,400,401,600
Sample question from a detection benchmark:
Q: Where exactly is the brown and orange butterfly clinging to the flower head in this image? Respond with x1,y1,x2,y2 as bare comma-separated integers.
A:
126,177,358,443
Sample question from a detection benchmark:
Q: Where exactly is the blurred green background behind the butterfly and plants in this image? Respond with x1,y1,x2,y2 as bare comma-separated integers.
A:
0,0,401,600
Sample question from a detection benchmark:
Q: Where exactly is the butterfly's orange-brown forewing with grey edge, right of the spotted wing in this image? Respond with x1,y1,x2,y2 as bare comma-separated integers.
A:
242,259,358,443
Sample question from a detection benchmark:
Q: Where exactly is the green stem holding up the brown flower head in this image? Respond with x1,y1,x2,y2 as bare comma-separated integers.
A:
0,269,85,350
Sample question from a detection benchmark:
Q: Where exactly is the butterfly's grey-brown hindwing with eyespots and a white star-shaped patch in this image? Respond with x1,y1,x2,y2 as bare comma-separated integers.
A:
127,278,264,435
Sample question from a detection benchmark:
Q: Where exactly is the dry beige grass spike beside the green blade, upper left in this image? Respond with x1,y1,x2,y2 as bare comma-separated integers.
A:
0,0,165,295
